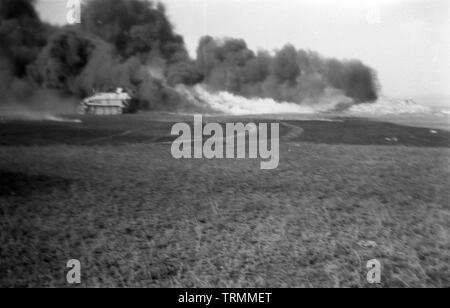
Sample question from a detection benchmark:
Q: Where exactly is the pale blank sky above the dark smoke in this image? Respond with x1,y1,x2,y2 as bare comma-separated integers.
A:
38,0,450,106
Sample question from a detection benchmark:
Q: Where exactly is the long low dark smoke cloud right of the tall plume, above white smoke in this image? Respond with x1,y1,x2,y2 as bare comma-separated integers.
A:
197,36,378,103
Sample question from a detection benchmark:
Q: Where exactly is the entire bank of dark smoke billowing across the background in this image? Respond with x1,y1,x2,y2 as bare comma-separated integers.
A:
0,0,377,116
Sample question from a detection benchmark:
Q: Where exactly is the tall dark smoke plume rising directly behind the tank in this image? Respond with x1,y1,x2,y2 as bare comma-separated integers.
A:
23,0,192,109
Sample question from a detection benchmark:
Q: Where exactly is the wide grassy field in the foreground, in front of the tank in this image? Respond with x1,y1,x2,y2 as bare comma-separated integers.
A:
0,113,450,287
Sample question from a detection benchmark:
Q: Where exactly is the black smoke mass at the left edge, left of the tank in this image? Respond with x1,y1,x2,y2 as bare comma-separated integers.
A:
0,0,73,119
